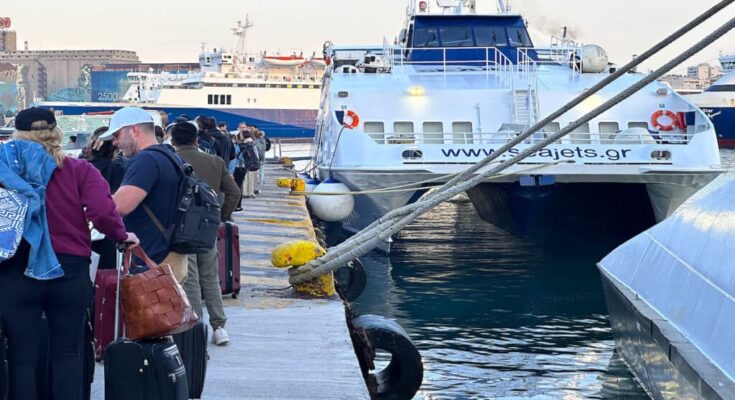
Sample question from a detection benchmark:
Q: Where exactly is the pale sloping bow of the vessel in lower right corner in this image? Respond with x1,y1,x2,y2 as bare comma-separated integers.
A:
598,174,735,400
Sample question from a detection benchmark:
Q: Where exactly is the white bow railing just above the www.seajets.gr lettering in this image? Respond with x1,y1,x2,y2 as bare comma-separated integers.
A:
367,131,694,145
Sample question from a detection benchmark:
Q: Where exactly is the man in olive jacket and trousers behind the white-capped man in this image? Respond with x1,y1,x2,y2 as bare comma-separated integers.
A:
171,122,240,346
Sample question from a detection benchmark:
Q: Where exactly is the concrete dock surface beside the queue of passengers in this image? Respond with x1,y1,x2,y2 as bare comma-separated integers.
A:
92,164,370,400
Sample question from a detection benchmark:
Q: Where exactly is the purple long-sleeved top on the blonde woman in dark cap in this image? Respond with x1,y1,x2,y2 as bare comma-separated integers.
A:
46,157,127,257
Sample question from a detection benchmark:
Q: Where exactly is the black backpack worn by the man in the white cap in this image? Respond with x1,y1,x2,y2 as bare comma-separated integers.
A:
143,148,222,254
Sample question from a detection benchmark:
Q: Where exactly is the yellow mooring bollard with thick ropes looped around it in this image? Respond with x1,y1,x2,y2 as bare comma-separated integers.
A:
271,240,337,297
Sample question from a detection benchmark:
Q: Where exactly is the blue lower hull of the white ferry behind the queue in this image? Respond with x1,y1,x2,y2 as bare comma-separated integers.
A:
39,104,317,138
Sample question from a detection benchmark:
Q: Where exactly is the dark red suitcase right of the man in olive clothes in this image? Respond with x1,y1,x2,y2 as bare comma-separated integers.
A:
217,222,240,299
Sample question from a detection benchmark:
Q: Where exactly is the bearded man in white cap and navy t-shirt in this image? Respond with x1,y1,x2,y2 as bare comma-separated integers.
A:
99,107,187,282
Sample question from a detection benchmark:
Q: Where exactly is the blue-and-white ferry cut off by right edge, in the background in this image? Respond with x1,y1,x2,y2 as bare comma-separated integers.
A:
688,70,735,148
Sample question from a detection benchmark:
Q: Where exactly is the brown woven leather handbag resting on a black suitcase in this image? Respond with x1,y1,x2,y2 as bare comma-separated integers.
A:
120,247,199,340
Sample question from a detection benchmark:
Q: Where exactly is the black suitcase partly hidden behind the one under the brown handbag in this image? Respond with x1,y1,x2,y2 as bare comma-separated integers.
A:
173,322,209,399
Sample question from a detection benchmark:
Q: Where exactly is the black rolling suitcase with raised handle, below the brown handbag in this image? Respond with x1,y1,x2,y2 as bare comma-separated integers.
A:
104,245,189,400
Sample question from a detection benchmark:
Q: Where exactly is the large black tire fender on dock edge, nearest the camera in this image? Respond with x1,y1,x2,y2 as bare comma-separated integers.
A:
352,314,424,400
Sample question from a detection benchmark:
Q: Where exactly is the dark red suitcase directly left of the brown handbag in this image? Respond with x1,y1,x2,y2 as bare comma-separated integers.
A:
94,269,123,361
